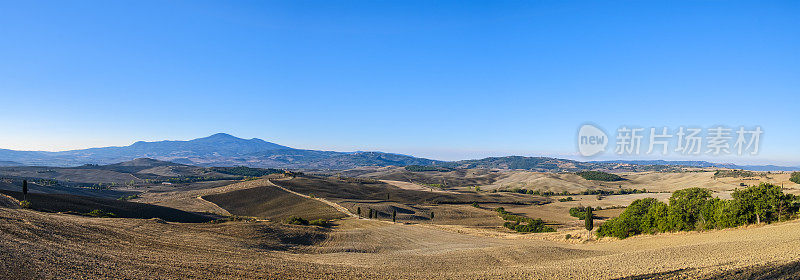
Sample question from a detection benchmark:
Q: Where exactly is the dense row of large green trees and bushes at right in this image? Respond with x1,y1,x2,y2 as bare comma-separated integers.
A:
597,183,800,238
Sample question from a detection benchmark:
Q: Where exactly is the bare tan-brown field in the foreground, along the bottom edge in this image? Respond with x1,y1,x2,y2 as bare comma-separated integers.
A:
0,203,800,279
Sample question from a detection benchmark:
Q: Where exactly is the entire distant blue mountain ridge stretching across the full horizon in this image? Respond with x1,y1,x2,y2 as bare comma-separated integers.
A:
0,133,800,172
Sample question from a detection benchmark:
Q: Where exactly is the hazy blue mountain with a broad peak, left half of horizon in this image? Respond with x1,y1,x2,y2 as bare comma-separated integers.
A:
0,133,438,169
